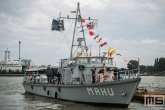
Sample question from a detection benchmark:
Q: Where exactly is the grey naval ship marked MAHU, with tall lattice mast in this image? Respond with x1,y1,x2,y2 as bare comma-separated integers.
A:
22,3,141,107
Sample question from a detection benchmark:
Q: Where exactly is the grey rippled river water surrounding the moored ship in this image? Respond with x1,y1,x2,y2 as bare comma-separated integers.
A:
0,76,165,110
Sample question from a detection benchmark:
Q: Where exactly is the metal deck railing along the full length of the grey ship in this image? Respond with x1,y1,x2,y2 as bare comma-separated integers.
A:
23,69,140,85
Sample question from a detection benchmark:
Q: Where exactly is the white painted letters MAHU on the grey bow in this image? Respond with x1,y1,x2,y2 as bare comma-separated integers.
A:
86,87,114,96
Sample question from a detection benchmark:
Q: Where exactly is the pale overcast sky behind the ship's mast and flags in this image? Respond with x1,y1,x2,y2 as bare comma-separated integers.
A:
0,0,165,68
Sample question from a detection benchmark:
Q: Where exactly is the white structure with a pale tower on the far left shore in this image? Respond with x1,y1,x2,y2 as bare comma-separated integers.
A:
0,48,22,72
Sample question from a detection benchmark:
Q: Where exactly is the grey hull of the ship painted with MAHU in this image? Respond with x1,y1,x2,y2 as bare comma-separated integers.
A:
23,78,141,105
